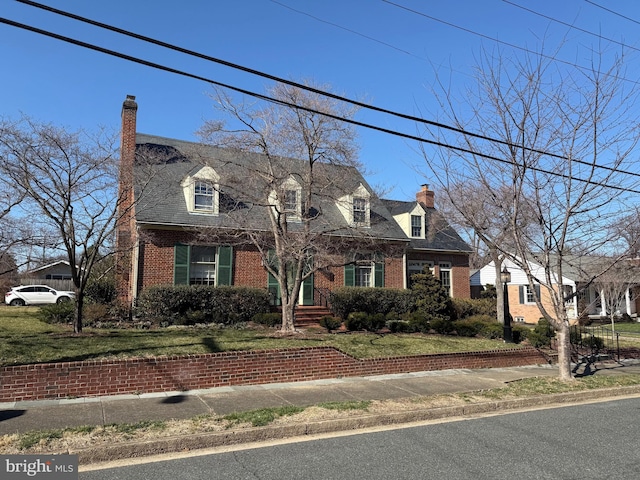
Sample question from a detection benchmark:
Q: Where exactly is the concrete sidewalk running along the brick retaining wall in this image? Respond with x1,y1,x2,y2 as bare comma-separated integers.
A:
0,363,640,435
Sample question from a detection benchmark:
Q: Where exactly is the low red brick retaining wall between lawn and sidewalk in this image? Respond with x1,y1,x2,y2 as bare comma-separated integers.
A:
0,347,547,402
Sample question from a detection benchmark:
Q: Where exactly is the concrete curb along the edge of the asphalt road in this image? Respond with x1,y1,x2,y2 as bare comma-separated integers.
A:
70,385,640,465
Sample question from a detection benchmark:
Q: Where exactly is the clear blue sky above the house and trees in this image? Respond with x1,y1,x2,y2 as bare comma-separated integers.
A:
0,0,640,200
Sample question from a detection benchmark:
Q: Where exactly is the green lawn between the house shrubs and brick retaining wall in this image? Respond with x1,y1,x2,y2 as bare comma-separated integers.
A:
0,307,514,365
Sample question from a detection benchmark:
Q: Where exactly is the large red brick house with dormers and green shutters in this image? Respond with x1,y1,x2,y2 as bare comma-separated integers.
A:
116,96,469,314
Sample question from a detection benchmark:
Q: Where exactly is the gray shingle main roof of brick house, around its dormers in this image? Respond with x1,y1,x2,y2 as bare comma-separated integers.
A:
135,133,407,241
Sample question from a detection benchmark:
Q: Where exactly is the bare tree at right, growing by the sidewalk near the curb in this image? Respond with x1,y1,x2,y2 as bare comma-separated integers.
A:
425,47,638,380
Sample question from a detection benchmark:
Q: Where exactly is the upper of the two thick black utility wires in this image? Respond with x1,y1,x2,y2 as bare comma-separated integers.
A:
17,0,624,176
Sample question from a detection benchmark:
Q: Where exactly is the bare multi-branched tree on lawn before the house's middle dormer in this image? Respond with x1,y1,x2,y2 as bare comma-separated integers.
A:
200,80,384,332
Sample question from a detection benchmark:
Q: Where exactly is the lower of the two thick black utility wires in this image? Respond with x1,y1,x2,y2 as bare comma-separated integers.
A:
0,17,640,194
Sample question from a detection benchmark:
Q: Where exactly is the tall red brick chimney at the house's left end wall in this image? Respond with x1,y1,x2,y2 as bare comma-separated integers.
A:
116,95,138,307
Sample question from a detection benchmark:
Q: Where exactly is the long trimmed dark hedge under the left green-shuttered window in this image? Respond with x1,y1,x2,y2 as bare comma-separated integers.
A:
136,285,269,325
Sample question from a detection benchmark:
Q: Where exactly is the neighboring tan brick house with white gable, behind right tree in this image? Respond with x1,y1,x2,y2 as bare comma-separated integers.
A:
470,260,579,324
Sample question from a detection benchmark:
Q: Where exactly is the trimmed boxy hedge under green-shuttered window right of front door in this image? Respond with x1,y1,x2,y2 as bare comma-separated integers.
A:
330,287,414,320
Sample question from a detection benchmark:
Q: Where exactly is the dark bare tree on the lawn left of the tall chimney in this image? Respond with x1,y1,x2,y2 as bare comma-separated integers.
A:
0,118,118,333
